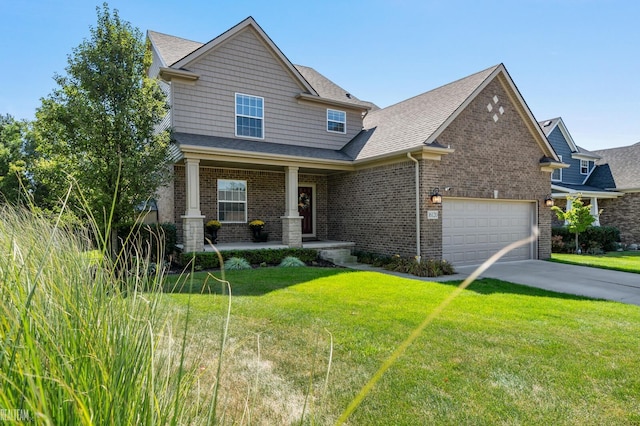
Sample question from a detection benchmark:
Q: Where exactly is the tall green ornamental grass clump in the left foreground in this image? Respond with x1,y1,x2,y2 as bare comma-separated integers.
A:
0,207,204,425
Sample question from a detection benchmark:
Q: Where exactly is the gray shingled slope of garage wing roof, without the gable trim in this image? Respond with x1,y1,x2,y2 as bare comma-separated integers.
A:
343,65,501,159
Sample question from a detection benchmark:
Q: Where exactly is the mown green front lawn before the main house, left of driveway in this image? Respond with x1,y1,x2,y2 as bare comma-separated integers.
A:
165,268,640,425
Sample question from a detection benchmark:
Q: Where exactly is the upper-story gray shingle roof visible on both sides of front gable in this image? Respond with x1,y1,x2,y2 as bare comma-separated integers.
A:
147,30,378,109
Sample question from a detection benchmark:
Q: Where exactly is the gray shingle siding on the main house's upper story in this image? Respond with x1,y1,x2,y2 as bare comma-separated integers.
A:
172,28,362,149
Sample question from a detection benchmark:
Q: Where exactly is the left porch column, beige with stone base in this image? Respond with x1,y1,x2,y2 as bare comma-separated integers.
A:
182,158,204,253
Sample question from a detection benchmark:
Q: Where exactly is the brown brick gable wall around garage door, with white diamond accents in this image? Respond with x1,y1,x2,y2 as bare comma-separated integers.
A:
434,79,551,259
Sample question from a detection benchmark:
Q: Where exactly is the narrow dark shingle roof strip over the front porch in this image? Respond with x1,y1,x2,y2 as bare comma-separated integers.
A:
172,132,352,161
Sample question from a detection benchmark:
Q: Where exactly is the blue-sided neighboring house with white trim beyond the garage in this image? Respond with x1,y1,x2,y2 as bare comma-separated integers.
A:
539,118,622,226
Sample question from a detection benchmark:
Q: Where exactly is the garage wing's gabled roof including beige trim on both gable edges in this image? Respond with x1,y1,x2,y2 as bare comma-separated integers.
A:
343,64,559,162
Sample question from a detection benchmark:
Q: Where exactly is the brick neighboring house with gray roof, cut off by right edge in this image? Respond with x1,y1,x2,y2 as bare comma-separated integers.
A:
590,142,640,244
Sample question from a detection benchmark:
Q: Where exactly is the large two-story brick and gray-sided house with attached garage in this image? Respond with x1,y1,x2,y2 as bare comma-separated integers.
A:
148,18,563,265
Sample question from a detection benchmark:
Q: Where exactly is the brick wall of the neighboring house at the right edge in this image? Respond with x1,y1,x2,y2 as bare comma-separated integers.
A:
598,192,640,244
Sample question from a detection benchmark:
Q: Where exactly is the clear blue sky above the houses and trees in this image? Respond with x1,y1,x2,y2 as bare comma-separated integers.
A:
0,0,640,150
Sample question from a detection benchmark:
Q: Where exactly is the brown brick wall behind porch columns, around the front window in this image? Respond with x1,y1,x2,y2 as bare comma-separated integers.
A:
174,165,327,243
